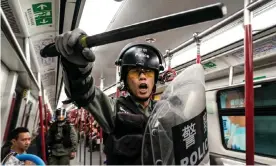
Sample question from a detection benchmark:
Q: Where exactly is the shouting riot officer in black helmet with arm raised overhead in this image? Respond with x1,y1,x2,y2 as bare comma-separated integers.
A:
56,29,164,165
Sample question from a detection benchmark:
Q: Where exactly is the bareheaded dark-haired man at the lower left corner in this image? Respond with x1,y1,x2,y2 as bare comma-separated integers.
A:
1,127,32,165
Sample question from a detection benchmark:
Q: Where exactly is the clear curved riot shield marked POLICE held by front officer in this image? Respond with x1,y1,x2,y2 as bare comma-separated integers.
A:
142,64,209,165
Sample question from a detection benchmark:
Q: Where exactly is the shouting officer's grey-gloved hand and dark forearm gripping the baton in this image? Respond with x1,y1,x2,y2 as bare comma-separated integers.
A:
55,29,95,107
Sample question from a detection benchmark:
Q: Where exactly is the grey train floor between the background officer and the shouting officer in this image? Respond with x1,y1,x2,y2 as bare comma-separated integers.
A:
70,140,106,165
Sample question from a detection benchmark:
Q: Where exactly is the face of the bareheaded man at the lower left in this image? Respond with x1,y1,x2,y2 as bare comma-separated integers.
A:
12,132,31,151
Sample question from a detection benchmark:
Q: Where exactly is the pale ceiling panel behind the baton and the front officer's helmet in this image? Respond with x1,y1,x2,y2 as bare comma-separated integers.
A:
88,0,243,87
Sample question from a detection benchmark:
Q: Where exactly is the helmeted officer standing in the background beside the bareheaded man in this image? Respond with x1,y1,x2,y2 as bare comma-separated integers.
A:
47,108,77,165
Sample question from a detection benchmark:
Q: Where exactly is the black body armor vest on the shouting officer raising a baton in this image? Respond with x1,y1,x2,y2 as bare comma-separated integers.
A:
104,96,154,165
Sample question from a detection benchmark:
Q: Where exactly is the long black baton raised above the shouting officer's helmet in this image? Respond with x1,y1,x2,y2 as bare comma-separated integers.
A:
40,3,227,58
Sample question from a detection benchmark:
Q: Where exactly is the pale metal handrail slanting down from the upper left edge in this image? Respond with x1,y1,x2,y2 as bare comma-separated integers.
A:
0,8,40,90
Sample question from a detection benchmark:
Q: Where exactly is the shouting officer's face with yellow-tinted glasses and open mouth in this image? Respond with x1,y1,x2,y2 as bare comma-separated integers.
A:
127,68,155,99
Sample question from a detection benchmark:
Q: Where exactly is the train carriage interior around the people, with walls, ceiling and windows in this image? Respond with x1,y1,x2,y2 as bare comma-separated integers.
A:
1,0,276,165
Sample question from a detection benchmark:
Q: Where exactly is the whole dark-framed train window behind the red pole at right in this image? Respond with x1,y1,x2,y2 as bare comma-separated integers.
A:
217,82,276,157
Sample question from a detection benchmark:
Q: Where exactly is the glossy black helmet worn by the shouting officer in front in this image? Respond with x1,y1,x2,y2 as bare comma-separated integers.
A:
115,43,165,83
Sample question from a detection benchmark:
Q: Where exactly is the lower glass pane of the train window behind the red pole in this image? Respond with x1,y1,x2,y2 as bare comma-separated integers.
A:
222,116,276,157
